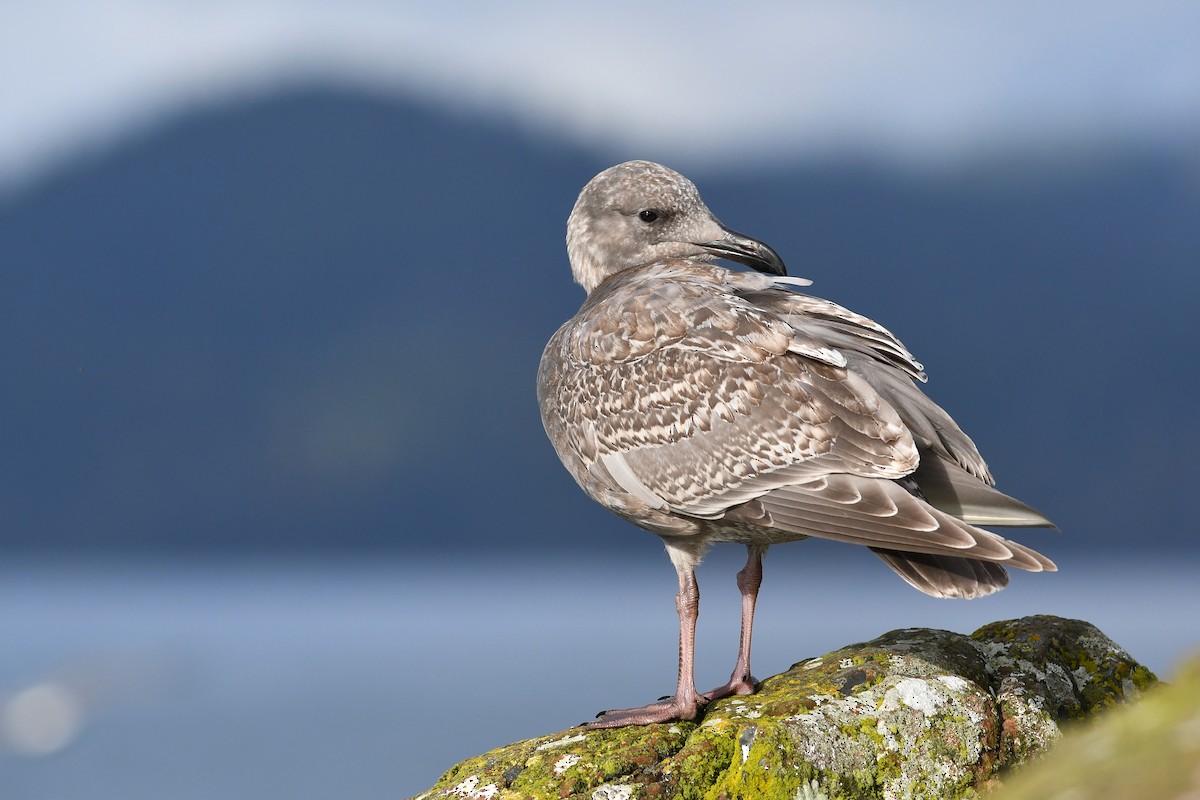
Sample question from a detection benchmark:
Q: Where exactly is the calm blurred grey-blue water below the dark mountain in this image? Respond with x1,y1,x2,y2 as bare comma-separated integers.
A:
0,542,1200,800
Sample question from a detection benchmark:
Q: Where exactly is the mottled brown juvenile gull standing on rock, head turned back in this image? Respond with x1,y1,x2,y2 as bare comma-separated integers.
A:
538,161,1055,728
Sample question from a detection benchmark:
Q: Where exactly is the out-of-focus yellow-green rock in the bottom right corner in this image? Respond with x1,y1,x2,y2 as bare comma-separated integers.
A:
996,656,1200,800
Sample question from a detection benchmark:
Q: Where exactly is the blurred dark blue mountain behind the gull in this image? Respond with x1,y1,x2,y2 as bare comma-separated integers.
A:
0,82,1200,561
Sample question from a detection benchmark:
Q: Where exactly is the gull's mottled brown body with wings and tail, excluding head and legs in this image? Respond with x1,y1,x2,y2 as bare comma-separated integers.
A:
539,261,1055,578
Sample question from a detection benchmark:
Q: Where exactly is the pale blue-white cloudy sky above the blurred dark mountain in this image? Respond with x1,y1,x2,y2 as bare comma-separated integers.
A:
0,0,1200,192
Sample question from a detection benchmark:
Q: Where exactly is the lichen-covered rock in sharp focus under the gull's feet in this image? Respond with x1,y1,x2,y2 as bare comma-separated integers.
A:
418,616,1156,800
